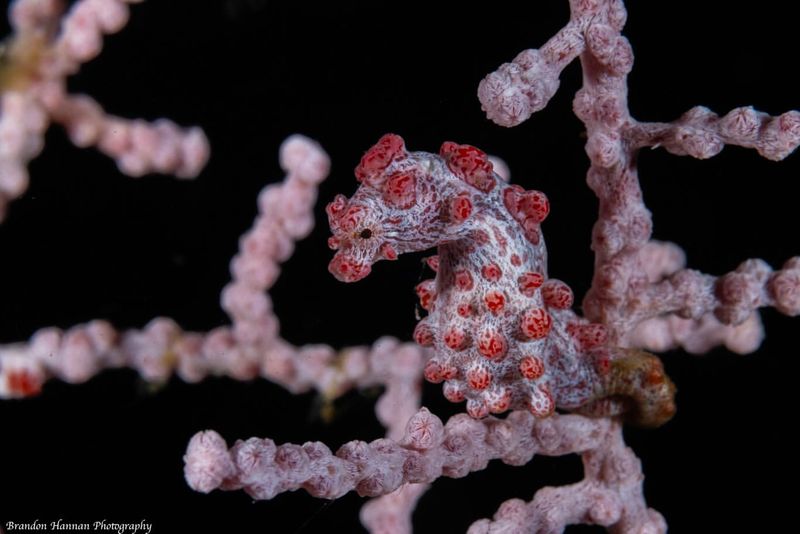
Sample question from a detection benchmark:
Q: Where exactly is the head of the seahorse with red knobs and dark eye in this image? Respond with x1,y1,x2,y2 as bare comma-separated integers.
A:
326,134,494,282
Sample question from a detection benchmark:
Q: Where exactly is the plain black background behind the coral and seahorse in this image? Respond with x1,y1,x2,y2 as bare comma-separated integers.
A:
0,0,800,534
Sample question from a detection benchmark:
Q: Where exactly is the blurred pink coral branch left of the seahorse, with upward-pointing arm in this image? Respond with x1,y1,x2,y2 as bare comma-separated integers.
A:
0,136,384,400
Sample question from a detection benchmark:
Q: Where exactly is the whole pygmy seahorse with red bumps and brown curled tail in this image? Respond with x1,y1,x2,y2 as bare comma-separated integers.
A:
327,134,675,426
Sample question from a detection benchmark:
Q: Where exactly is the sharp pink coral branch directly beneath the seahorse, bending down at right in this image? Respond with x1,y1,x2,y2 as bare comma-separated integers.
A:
184,408,665,533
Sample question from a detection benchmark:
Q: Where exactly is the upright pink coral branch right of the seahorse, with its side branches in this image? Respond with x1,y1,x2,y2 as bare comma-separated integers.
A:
478,0,800,352
